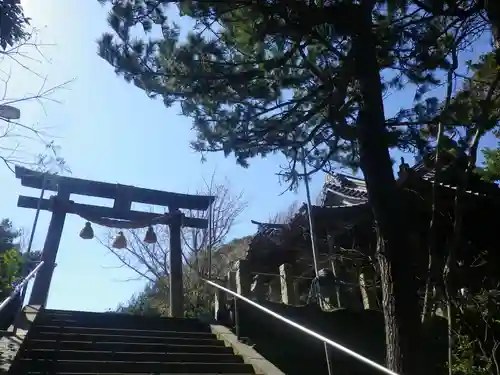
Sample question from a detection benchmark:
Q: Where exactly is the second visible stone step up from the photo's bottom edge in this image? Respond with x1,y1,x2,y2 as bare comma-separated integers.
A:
23,350,243,363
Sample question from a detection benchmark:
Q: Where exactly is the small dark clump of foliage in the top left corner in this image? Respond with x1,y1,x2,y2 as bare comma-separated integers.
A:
0,0,30,50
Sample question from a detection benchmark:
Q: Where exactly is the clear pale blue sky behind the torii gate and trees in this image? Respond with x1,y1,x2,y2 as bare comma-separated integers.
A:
0,0,496,311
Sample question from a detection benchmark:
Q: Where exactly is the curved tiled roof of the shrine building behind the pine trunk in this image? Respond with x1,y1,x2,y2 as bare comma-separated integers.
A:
244,151,500,268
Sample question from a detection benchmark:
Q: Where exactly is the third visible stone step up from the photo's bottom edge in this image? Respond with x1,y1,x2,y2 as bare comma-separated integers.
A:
25,339,234,354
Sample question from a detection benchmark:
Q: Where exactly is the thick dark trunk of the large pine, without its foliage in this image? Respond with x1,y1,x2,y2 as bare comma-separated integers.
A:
353,3,422,374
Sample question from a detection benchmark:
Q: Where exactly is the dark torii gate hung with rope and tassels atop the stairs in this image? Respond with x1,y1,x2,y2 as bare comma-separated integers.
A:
15,166,215,317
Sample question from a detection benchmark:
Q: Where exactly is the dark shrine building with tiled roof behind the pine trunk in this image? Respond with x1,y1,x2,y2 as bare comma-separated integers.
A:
229,156,500,309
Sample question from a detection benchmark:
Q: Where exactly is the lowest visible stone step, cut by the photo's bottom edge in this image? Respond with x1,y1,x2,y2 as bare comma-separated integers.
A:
16,358,255,374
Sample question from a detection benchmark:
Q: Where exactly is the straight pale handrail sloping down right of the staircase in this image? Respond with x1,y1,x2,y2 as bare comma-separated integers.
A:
202,278,399,375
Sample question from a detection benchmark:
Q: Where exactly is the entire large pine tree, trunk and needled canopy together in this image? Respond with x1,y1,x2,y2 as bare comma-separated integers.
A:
94,0,488,373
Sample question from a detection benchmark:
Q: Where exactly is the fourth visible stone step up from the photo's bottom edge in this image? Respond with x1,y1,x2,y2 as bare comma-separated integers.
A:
29,330,224,346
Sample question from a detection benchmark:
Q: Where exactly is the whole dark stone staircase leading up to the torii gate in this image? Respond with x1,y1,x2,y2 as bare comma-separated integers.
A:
9,310,262,375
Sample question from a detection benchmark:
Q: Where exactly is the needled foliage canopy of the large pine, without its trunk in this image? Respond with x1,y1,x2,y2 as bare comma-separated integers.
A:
94,0,477,187
